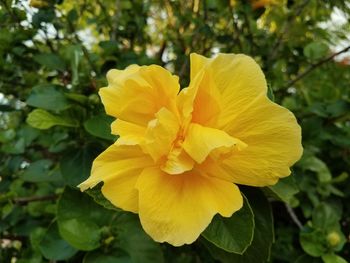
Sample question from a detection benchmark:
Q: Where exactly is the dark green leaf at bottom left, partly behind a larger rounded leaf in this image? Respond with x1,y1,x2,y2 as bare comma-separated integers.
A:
39,224,77,260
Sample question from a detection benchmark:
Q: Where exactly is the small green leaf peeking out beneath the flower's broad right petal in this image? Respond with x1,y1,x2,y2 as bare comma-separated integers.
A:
268,175,299,203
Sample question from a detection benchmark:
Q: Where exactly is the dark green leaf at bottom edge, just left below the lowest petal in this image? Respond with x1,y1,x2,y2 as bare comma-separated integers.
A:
114,213,164,263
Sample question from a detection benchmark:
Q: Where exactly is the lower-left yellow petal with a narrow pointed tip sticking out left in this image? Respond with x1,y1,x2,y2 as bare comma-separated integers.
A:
78,145,154,212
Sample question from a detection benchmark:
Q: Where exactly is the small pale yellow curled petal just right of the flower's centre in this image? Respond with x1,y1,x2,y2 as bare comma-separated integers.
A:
182,123,247,163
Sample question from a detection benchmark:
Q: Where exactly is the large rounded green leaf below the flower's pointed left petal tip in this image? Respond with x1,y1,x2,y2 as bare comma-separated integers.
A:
57,187,112,251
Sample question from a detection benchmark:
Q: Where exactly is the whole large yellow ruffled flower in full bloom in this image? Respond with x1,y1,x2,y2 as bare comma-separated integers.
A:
79,54,302,246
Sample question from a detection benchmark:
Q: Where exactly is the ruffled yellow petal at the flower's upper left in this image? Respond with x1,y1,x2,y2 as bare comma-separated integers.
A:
99,65,179,126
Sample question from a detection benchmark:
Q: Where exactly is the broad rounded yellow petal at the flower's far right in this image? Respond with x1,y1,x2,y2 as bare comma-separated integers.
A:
209,97,303,186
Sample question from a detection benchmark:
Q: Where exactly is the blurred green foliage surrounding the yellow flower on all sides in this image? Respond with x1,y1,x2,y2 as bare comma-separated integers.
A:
0,0,350,263
